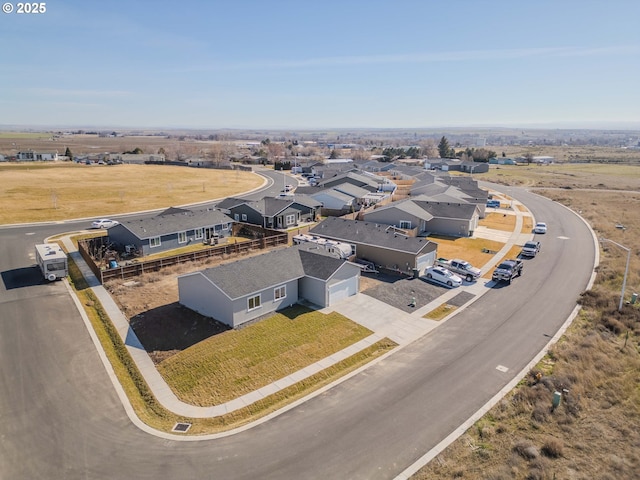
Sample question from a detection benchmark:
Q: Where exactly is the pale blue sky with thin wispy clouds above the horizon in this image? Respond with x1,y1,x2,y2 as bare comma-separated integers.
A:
0,0,640,129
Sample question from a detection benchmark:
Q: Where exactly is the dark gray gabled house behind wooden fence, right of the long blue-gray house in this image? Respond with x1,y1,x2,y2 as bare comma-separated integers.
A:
216,195,322,229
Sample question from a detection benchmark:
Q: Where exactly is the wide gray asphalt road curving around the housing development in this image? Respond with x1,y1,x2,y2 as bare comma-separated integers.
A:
0,188,595,479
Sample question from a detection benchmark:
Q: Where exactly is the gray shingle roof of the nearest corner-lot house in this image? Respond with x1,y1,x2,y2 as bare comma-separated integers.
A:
200,245,344,299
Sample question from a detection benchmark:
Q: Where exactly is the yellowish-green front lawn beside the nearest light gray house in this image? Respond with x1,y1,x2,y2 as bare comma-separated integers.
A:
158,305,371,406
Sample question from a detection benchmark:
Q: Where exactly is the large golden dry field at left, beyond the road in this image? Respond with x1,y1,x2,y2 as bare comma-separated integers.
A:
0,162,264,224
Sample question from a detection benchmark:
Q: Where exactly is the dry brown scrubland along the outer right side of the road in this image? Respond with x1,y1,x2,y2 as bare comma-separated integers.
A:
412,166,640,480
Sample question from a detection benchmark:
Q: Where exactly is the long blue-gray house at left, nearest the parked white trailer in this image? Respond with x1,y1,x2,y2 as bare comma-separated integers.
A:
109,208,233,255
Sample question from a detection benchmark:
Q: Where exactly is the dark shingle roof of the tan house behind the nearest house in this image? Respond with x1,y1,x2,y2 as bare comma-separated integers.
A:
309,217,437,254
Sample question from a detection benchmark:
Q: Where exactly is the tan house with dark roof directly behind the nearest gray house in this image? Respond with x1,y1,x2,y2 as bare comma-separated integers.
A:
309,217,438,274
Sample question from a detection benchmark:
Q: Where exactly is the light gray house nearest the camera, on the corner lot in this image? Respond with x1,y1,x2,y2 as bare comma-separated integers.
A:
178,245,360,328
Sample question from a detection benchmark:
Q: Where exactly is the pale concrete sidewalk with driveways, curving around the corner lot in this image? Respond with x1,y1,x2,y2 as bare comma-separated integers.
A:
63,195,532,418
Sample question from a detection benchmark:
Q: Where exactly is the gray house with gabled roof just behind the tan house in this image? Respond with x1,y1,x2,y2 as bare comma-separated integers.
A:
364,198,480,237
